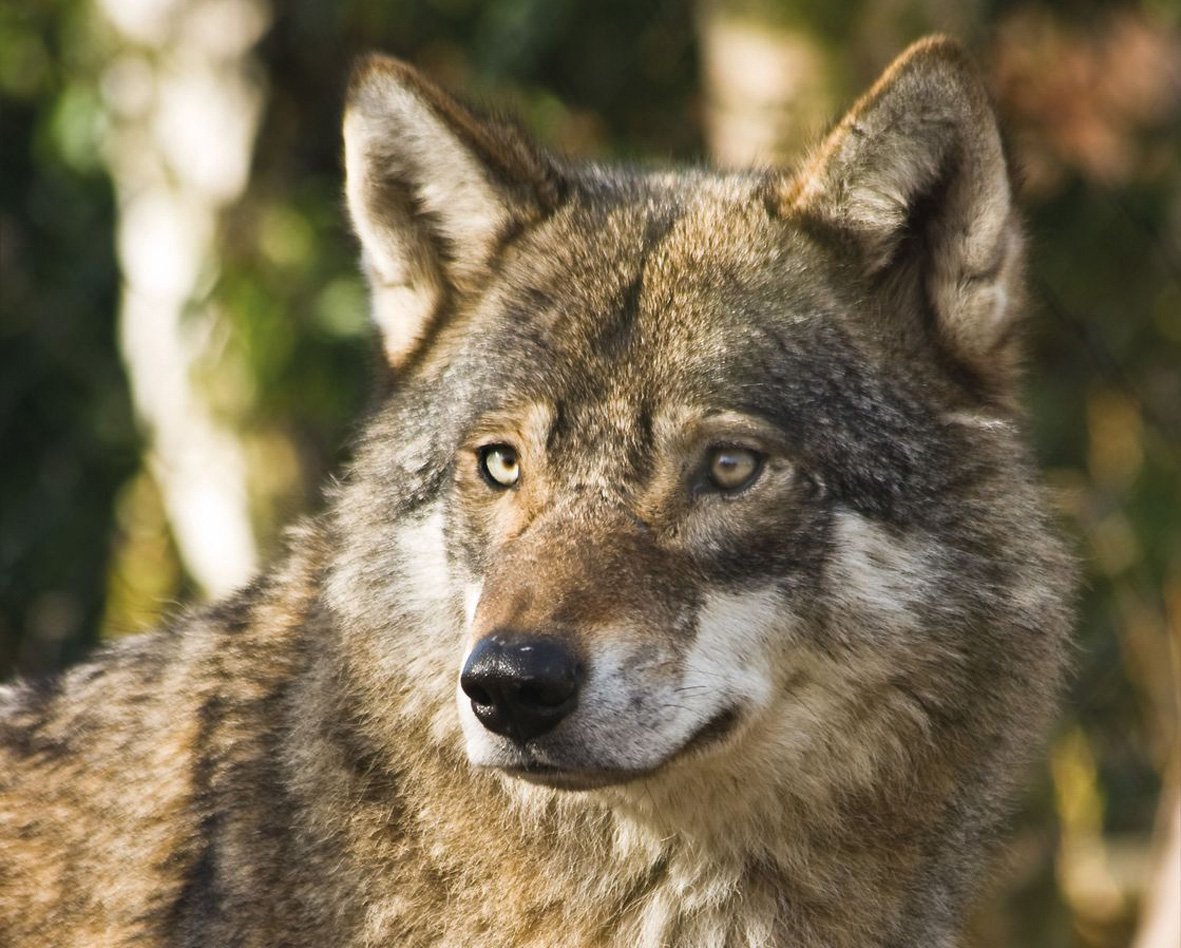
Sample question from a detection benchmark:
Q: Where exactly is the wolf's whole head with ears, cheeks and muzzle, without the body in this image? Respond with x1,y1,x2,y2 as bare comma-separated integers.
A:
331,40,1068,821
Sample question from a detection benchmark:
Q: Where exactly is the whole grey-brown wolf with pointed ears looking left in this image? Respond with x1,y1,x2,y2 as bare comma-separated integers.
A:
0,38,1072,948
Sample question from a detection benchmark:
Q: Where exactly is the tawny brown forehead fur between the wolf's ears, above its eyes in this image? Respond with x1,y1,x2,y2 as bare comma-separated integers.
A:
443,171,835,399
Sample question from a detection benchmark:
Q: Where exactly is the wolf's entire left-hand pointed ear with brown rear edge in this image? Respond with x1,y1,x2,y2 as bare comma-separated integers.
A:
345,55,562,366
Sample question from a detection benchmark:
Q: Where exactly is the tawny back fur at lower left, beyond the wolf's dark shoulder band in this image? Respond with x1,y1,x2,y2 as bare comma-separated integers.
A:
0,597,244,946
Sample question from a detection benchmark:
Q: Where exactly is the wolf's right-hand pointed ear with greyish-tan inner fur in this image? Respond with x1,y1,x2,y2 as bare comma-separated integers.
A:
784,37,1023,392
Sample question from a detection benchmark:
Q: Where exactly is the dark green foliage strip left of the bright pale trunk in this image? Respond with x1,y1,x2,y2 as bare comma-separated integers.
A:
0,4,139,672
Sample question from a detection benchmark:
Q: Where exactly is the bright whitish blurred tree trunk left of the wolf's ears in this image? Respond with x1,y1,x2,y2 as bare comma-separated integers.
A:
100,0,269,595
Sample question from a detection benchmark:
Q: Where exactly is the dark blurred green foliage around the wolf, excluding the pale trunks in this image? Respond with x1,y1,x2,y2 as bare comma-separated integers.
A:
0,0,1181,948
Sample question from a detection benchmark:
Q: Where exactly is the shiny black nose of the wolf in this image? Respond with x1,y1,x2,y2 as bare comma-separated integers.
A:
459,632,583,744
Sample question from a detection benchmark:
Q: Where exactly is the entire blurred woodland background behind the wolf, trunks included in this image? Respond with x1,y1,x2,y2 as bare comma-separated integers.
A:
0,0,1181,948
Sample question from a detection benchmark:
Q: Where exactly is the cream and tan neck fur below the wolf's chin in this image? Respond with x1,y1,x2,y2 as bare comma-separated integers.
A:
363,731,934,948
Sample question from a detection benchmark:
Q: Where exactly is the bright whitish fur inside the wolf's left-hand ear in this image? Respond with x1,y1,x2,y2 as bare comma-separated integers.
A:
344,72,508,364
